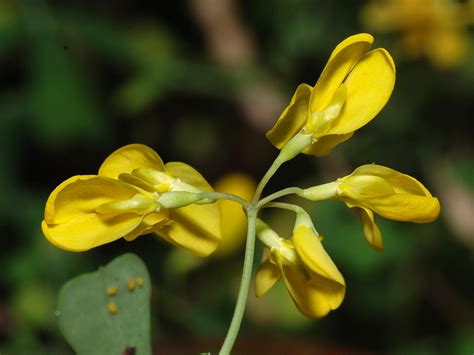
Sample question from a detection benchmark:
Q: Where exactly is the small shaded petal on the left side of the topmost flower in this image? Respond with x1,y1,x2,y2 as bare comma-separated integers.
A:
267,84,313,148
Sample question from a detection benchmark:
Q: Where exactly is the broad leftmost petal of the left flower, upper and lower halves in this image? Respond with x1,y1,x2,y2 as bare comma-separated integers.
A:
41,175,148,251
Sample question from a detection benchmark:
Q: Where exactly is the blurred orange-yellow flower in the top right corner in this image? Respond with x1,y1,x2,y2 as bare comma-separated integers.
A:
361,0,474,69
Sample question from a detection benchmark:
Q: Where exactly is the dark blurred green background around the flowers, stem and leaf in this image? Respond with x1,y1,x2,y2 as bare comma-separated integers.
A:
0,0,474,355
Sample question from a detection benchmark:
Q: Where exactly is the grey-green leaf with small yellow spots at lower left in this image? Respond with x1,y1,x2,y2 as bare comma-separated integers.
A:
57,254,151,355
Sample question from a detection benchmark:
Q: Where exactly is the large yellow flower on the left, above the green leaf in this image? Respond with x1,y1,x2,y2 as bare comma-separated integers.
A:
41,144,221,256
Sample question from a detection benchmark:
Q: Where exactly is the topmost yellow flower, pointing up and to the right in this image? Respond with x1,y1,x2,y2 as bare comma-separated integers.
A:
267,33,395,156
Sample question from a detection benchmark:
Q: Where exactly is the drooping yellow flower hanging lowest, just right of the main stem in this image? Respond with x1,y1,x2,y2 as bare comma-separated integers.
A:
255,216,346,318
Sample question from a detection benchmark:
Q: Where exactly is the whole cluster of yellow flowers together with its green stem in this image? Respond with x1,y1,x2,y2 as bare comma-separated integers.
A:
42,33,440,328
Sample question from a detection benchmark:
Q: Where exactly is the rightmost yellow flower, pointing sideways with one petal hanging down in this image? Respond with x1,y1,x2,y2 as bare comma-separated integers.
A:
301,164,440,251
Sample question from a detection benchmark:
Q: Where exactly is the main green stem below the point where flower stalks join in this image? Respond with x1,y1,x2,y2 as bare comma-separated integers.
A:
219,206,258,355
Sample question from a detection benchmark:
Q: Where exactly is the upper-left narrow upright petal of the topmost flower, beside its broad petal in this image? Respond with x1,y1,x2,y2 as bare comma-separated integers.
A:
310,33,374,112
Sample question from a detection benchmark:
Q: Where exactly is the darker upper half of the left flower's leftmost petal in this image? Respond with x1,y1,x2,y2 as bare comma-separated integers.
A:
44,175,143,224
